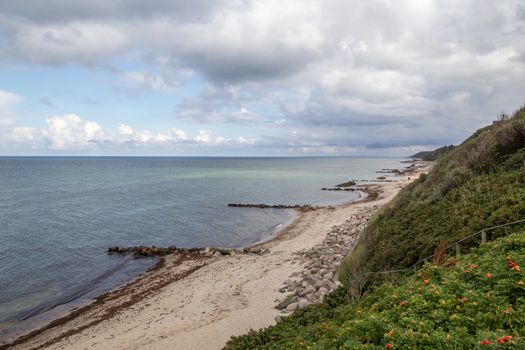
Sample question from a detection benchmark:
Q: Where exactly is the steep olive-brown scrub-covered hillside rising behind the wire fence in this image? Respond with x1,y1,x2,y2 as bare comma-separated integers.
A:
339,107,525,292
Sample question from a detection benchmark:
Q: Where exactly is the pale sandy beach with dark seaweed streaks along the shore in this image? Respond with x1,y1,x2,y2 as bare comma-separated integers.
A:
6,165,428,349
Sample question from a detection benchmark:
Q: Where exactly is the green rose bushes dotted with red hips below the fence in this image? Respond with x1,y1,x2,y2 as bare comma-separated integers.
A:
226,232,525,350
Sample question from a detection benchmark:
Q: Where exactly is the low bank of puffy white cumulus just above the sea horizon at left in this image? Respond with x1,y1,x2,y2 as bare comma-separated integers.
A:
0,114,255,152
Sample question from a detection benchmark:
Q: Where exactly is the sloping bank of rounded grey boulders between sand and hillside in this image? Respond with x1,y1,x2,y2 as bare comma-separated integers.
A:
276,205,379,318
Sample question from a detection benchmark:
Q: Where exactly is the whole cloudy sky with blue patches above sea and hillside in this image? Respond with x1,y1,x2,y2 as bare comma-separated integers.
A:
0,0,525,156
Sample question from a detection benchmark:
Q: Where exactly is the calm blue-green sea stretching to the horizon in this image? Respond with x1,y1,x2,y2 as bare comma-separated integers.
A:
0,157,402,340
